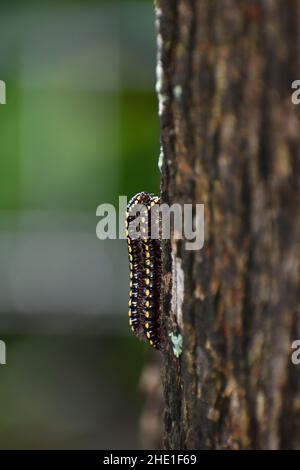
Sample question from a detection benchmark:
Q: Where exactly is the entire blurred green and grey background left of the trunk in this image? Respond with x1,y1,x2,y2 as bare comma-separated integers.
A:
0,0,159,449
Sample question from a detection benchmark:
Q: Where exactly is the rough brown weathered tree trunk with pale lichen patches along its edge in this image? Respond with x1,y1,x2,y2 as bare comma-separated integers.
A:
155,0,300,449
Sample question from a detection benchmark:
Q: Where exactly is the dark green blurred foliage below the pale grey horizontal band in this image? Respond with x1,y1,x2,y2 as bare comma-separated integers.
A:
0,335,145,449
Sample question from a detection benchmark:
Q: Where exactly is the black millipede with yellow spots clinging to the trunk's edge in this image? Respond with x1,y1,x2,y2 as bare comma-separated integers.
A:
126,192,161,349
